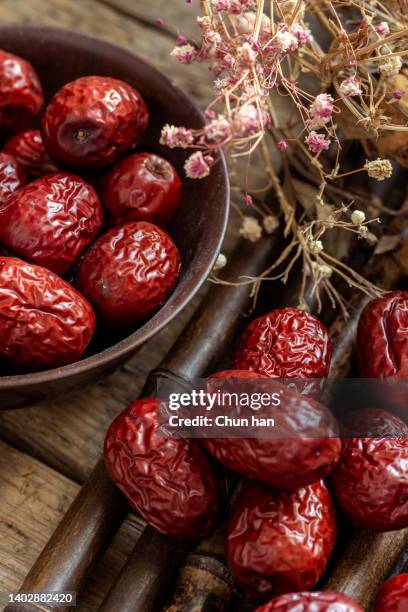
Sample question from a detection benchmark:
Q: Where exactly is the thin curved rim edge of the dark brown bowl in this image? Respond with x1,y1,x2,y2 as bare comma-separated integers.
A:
0,22,230,391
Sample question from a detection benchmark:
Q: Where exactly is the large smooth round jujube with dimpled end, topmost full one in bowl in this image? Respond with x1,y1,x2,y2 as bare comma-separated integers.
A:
42,76,148,169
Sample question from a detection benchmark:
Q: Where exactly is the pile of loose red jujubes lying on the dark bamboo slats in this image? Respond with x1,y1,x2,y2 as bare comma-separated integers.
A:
105,302,408,612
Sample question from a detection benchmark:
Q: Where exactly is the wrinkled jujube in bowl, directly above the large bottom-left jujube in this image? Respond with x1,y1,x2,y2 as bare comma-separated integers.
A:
0,172,103,274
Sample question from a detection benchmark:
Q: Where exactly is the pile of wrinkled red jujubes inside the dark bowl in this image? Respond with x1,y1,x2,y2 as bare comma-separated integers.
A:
0,51,182,370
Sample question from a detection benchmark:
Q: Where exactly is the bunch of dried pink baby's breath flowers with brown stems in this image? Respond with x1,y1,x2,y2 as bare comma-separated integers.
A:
160,0,408,312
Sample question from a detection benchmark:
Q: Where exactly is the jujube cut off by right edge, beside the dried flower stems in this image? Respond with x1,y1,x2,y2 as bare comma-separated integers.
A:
357,291,408,378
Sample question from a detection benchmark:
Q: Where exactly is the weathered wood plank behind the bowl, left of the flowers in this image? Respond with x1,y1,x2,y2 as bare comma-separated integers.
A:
0,0,211,103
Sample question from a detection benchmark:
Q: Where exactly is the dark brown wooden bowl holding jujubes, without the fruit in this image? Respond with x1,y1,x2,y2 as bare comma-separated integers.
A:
0,24,229,409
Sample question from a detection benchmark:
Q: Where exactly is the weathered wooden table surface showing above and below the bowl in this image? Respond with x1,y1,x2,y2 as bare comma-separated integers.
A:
0,0,230,610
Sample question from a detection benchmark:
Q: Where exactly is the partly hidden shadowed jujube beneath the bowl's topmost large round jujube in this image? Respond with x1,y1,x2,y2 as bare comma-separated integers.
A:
3,130,59,178
